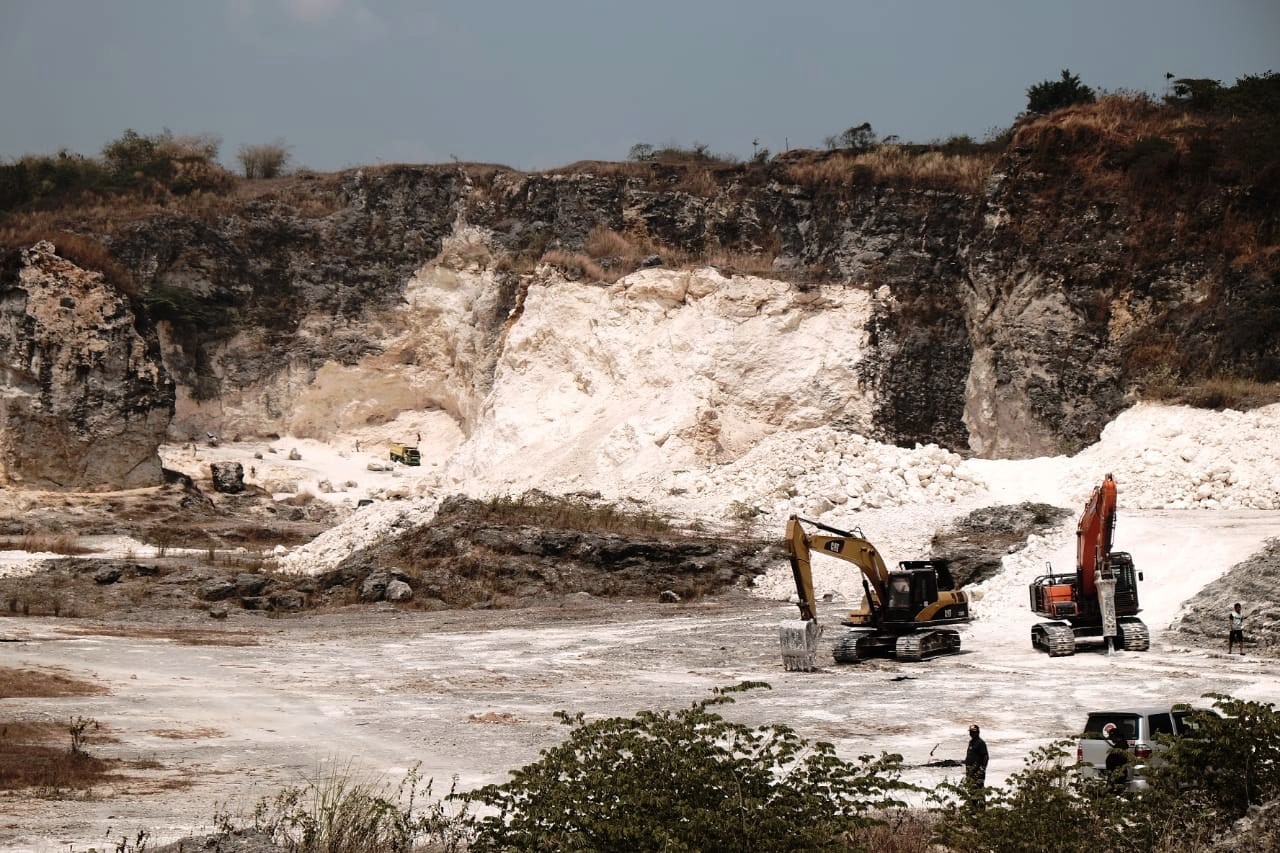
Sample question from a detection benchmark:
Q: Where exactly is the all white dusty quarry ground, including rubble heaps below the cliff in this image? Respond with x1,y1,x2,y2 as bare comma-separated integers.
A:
0,406,1280,852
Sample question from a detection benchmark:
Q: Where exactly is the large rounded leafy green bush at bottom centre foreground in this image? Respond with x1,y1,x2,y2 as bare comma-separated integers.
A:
465,683,910,852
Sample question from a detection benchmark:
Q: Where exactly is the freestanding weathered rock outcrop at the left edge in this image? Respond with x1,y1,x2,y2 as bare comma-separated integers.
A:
0,242,174,491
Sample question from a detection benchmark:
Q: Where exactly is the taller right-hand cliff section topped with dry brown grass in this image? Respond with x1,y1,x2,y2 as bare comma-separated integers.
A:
961,140,1280,456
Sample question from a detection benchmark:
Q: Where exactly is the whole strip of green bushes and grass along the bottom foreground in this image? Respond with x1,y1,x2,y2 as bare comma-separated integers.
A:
207,681,1280,853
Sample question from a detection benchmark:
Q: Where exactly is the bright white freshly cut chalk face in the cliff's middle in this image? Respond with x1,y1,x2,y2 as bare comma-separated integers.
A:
444,269,870,496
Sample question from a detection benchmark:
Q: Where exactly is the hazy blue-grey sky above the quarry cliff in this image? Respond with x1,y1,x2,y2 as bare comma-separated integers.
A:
0,0,1280,170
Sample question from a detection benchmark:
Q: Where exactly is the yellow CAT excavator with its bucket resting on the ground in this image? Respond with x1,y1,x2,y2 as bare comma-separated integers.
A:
778,515,972,671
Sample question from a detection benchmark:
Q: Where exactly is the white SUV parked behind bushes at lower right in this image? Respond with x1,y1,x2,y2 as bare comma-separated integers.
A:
1075,704,1213,790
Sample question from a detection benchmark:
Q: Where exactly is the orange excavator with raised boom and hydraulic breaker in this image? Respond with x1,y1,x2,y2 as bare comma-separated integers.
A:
1030,474,1151,657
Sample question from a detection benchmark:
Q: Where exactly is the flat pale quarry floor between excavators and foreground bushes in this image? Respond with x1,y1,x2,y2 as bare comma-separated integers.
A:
0,584,1280,853
